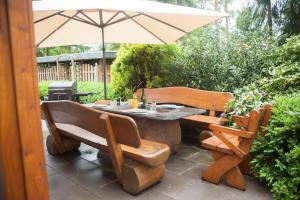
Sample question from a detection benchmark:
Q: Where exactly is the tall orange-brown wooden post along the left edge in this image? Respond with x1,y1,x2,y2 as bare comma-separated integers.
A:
0,0,49,200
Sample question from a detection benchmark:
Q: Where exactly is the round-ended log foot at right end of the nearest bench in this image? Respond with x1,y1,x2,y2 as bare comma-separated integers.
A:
122,160,165,194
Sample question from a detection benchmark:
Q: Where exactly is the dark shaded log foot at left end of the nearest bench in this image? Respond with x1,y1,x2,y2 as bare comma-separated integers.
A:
46,135,80,155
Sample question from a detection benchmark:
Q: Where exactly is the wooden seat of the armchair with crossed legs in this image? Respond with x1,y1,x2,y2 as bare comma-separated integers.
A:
201,134,239,154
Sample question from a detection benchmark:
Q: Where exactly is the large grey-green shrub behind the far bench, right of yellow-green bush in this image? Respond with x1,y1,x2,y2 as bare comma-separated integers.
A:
170,26,274,91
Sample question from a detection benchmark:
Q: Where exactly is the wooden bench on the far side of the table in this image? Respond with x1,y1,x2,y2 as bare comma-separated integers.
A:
137,87,233,139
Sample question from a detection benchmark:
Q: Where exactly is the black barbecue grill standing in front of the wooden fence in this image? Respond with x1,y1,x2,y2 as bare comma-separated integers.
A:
48,81,77,101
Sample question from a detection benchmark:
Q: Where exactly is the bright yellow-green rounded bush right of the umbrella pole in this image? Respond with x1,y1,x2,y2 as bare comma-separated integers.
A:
112,44,179,98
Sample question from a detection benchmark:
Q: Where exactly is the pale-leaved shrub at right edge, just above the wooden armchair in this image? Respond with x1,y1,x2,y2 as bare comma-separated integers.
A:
226,36,300,119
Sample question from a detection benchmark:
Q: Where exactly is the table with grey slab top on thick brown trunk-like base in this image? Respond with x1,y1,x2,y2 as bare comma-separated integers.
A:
90,104,205,152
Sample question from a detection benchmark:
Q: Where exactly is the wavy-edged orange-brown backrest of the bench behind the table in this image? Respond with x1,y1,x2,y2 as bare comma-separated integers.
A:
137,87,233,116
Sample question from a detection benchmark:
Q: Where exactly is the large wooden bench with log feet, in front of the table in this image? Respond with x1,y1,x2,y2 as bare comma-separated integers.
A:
42,101,170,194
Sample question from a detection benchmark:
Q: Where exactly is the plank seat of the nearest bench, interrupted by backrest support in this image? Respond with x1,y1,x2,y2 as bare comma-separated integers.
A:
55,123,170,167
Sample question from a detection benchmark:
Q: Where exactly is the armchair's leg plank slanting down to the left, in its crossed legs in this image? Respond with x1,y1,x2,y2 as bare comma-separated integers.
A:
202,151,241,184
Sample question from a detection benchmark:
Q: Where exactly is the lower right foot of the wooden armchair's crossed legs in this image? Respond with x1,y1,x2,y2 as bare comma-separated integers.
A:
224,166,246,190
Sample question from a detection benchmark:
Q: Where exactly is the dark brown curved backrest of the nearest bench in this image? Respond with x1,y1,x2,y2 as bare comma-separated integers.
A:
42,101,141,148
